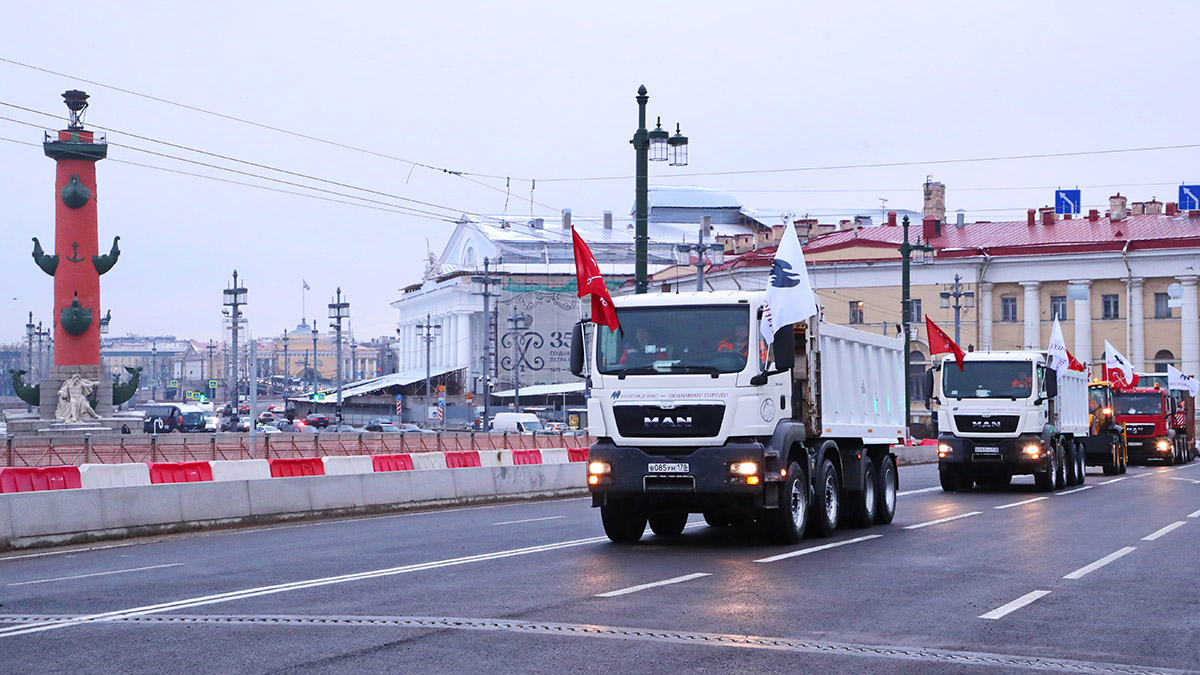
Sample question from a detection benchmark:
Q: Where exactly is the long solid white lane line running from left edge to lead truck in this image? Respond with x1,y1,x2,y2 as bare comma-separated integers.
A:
0,537,608,638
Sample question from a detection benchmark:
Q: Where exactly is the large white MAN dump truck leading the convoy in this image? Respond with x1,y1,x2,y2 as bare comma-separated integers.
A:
571,292,906,543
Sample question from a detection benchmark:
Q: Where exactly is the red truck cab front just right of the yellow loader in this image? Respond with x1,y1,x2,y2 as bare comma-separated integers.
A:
1112,380,1195,465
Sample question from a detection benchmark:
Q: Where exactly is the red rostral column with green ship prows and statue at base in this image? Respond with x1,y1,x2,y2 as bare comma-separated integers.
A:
8,90,140,434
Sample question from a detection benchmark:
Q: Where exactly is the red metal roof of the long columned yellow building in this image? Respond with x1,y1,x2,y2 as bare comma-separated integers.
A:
716,211,1200,269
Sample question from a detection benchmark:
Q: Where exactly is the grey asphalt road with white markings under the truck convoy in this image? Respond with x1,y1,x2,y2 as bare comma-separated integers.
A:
0,462,1200,674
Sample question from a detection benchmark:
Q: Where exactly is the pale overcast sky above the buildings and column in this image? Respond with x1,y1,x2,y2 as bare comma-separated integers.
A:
0,0,1200,342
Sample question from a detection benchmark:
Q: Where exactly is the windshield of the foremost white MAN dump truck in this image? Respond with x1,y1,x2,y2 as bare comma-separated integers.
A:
596,305,753,375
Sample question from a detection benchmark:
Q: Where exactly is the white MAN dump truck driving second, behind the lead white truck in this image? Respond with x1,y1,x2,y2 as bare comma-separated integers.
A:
935,351,1088,492
